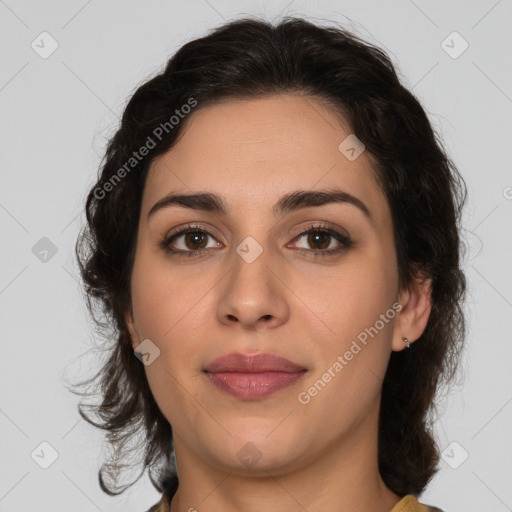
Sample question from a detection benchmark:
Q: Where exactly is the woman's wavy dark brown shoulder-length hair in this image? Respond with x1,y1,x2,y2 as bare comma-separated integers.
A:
72,18,466,496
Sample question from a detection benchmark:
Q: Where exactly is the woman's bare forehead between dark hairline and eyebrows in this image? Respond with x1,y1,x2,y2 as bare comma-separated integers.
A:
143,94,387,221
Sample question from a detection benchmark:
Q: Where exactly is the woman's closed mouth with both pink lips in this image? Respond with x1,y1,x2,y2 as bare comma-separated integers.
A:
203,353,307,400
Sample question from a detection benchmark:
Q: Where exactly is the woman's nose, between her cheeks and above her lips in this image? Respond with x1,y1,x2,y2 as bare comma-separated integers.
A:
217,246,290,330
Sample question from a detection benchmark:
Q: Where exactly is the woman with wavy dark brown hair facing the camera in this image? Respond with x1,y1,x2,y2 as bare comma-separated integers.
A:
77,18,466,512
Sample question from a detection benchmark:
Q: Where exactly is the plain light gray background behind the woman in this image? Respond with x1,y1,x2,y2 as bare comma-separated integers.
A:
0,0,512,512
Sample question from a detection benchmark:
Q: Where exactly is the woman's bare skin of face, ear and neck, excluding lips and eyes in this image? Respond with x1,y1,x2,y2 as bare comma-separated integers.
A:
126,94,430,512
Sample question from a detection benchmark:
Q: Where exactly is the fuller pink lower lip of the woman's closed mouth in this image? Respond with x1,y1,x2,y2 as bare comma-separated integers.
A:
206,370,306,400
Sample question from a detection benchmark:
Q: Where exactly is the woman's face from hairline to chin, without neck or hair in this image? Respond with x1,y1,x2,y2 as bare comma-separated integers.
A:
127,95,424,478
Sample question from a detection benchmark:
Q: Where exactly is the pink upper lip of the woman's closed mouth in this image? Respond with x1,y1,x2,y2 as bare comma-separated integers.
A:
204,353,306,373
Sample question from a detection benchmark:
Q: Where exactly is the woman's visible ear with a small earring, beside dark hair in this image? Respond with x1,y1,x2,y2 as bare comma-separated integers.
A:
392,274,432,352
